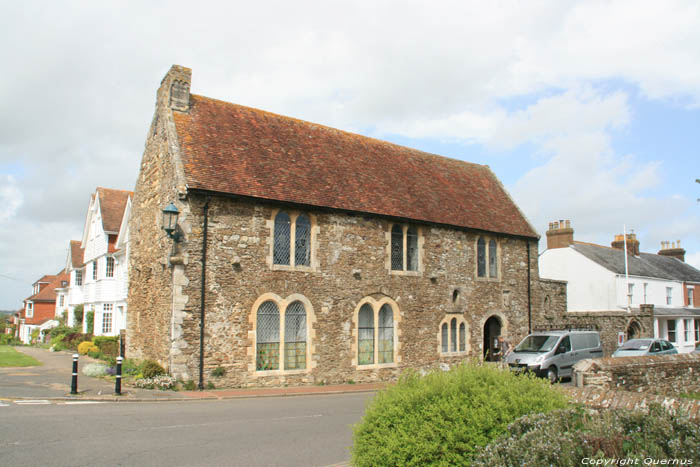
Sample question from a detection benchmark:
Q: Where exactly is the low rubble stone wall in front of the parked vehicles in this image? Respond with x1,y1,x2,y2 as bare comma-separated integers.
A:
571,354,700,395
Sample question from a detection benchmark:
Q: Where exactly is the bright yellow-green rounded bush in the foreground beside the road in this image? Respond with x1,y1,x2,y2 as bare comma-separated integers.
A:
352,364,568,466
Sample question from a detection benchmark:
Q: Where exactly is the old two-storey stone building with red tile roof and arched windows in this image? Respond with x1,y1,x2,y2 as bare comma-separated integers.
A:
127,66,566,386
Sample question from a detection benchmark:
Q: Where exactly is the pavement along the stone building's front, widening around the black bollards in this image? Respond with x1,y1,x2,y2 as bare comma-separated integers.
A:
0,347,386,402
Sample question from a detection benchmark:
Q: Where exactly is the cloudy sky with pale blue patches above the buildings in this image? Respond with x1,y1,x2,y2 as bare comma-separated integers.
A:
0,0,700,309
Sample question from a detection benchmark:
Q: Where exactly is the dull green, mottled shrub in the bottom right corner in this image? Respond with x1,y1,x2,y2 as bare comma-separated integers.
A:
472,405,700,467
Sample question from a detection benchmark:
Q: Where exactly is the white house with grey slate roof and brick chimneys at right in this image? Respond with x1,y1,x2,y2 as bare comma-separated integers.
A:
539,221,700,353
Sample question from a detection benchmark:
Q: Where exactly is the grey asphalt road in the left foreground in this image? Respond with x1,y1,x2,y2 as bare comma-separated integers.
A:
0,393,372,467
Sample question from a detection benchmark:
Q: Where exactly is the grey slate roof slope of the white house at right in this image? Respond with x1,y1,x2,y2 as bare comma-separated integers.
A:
571,242,700,282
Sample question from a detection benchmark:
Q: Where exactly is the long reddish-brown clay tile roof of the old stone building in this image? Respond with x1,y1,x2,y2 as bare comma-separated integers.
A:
173,95,539,238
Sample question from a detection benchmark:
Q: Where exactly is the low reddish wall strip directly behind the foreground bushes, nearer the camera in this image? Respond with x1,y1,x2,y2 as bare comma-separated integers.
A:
560,386,700,421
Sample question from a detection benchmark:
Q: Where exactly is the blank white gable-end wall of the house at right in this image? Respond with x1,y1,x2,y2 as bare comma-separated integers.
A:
539,248,618,311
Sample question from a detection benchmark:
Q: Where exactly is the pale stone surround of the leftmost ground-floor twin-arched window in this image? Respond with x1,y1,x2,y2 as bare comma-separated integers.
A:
246,293,316,378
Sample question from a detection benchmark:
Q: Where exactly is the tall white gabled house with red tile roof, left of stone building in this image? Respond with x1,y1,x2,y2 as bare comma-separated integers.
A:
56,187,133,336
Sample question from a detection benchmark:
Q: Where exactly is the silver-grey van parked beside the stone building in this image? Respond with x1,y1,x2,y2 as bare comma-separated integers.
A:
506,329,603,383
